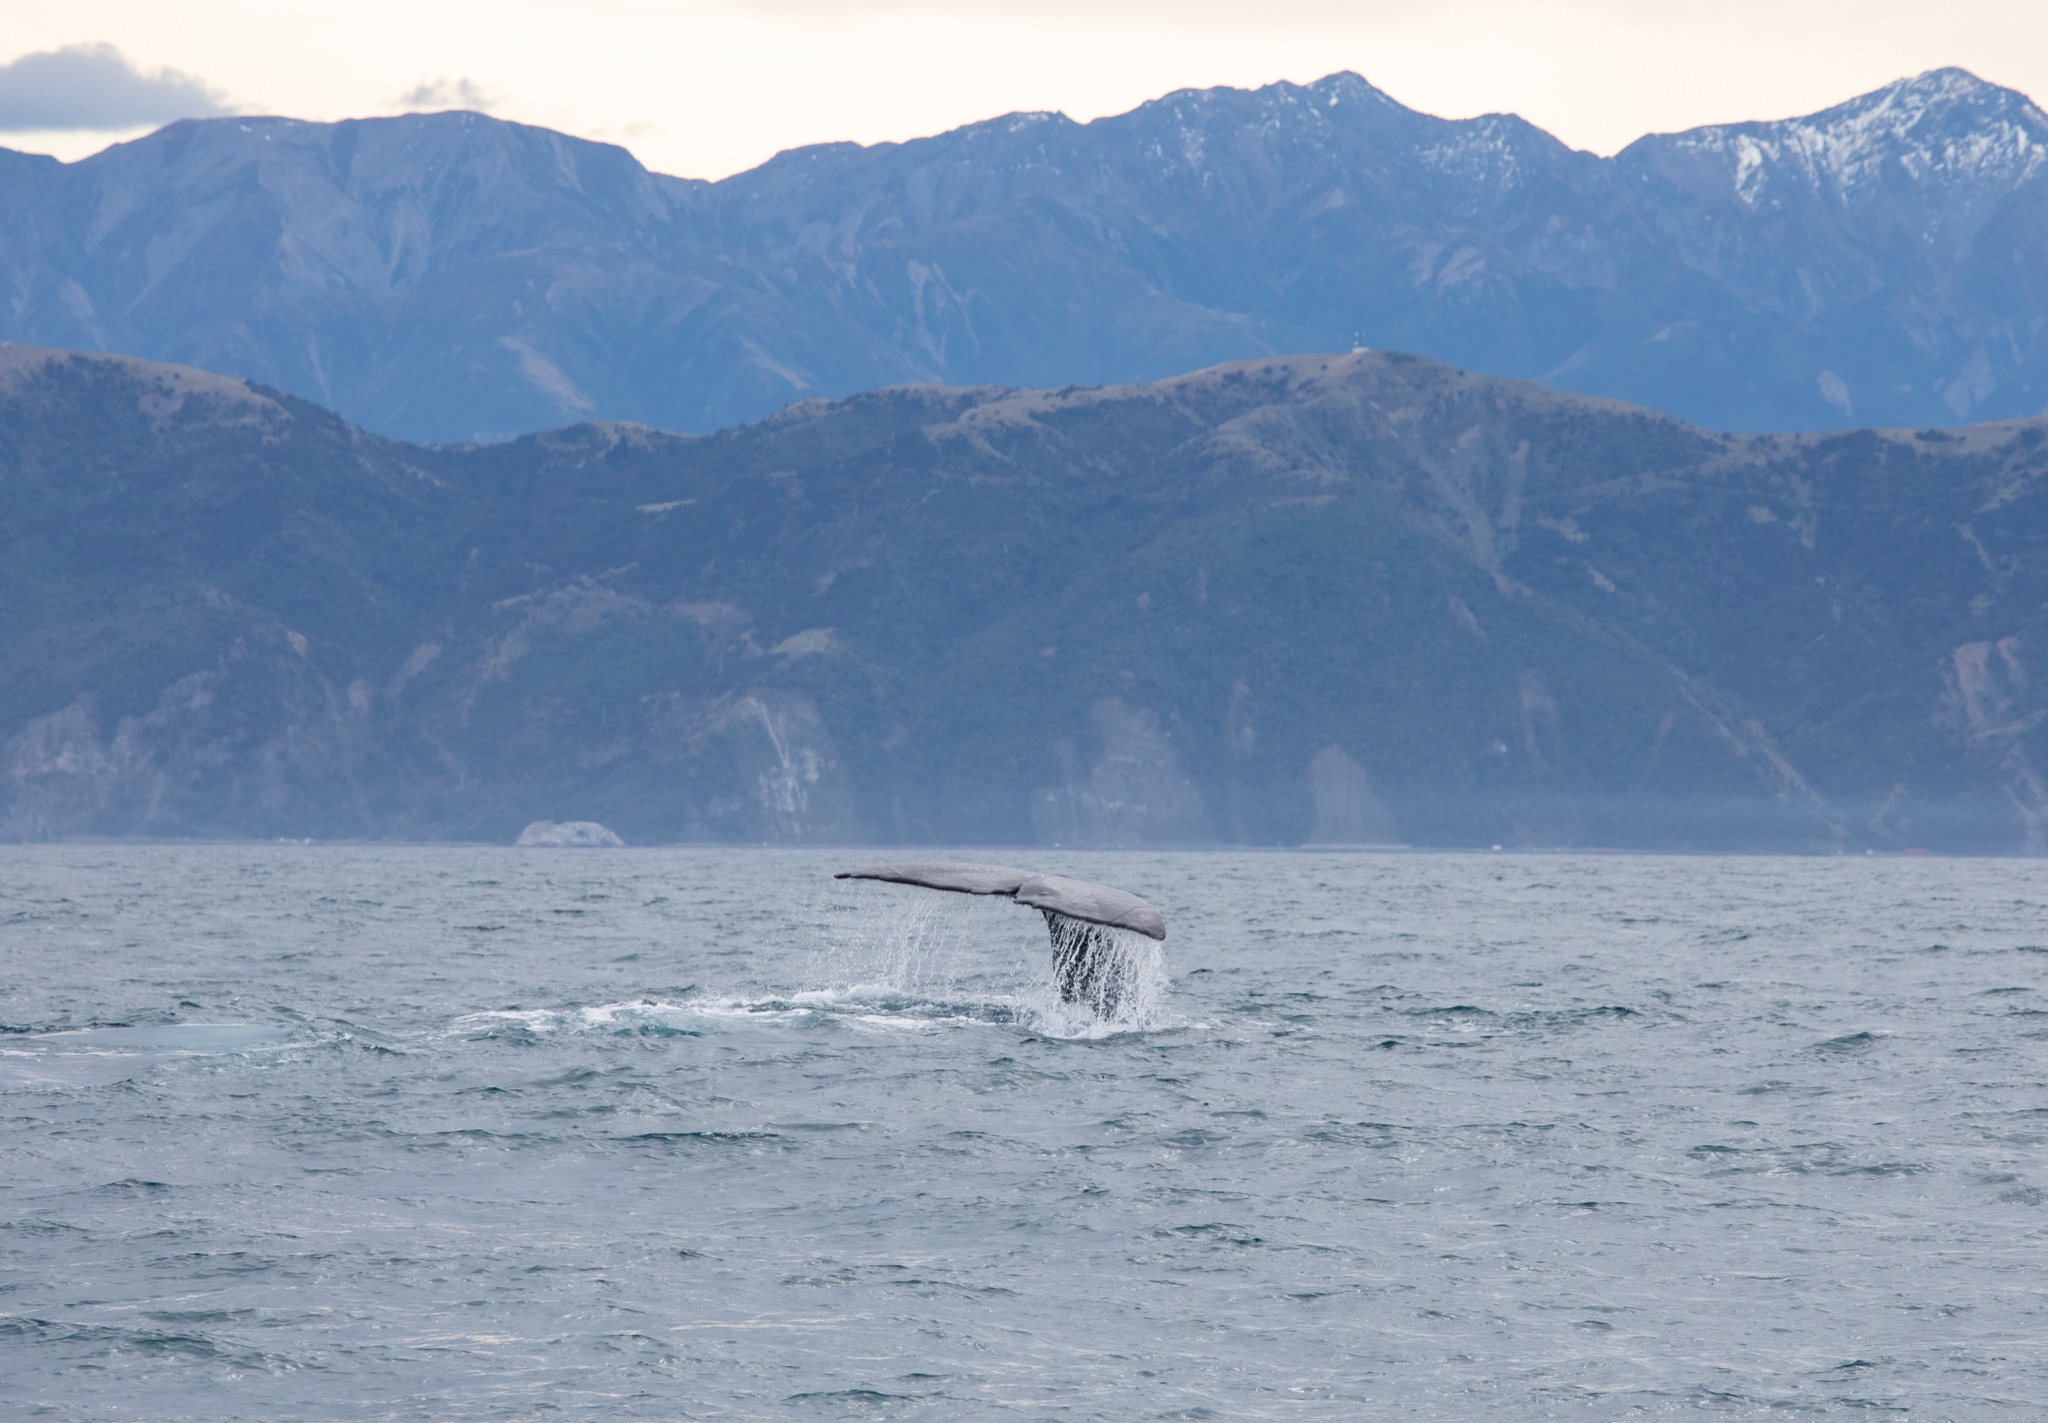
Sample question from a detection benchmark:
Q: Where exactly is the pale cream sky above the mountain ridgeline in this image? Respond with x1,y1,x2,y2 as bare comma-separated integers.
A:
0,0,2048,178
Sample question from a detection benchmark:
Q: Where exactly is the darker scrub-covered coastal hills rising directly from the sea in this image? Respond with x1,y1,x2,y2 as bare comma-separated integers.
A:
0,346,2048,850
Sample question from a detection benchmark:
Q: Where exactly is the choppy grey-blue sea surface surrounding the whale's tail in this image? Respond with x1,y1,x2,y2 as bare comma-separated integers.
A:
0,846,2048,1423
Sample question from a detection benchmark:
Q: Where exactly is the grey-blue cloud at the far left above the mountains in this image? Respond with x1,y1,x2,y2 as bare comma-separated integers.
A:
0,43,233,133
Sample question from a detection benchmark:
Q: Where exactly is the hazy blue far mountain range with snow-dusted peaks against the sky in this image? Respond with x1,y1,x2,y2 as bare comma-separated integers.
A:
0,70,2048,440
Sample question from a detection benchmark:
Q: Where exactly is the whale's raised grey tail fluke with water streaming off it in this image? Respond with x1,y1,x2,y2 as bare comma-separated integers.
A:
834,864,1165,1022
